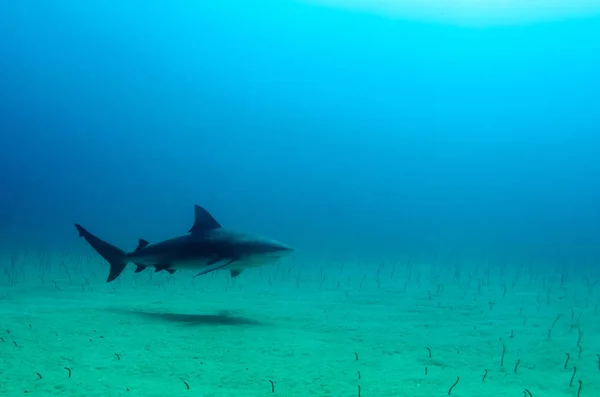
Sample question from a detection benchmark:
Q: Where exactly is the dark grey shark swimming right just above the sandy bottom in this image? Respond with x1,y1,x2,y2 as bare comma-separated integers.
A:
75,205,293,283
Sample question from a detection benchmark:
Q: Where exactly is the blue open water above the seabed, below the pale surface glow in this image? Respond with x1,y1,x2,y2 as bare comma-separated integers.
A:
0,1,600,266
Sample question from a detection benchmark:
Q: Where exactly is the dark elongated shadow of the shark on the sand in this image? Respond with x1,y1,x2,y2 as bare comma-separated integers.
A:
105,309,266,326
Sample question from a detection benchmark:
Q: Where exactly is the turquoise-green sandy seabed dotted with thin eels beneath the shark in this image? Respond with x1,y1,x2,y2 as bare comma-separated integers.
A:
0,258,600,397
